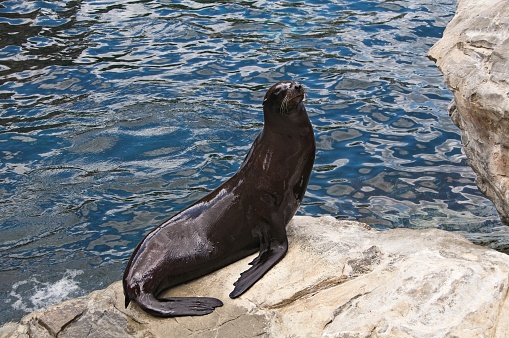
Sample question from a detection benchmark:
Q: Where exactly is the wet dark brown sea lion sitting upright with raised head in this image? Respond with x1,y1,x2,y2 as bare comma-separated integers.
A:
123,81,315,317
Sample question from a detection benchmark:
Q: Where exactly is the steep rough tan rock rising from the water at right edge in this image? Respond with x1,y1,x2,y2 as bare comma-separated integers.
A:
429,0,509,224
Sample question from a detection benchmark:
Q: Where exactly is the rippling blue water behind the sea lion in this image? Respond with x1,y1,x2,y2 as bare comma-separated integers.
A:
0,0,509,323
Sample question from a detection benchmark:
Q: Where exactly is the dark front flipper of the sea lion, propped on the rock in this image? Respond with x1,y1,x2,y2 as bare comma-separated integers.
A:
230,240,288,298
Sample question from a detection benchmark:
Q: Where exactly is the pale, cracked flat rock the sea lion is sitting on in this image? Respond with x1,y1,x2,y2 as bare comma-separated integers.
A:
0,216,509,338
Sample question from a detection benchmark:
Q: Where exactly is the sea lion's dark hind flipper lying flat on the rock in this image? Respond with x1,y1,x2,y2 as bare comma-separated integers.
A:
126,293,223,317
